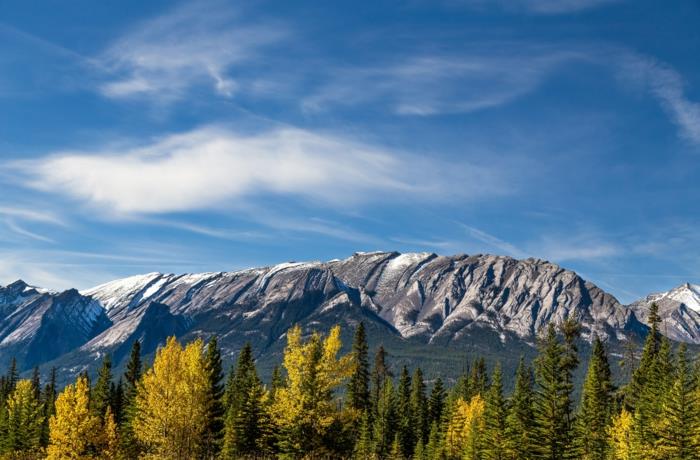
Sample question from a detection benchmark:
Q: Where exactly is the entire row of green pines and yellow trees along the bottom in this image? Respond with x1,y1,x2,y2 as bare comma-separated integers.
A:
0,306,700,460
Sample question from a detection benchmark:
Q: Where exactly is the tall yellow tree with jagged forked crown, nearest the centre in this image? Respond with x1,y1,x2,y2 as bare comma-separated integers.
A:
272,326,352,456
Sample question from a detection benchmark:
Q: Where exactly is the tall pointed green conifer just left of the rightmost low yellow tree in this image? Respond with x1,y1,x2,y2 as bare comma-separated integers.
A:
576,335,614,460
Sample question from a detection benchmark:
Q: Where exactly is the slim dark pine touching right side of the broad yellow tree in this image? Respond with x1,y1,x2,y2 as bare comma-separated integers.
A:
202,336,225,459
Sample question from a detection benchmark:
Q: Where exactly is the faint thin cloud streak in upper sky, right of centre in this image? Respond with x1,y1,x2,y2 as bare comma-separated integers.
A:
302,47,589,116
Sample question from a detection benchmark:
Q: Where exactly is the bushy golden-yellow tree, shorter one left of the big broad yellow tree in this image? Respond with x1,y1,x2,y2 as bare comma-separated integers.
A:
46,377,101,460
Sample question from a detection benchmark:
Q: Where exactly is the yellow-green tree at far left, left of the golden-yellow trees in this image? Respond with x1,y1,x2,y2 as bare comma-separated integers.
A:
4,380,44,453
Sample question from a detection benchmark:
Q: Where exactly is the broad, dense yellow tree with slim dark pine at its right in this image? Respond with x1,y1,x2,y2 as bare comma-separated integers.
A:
133,337,208,459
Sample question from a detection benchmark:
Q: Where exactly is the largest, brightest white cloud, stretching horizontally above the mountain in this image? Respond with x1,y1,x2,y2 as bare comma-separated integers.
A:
13,126,510,215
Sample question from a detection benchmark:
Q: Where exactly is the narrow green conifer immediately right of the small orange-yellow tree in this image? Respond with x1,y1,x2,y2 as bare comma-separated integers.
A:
484,364,509,460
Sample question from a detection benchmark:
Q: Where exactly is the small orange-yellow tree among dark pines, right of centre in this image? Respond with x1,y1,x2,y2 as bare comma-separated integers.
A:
445,395,485,459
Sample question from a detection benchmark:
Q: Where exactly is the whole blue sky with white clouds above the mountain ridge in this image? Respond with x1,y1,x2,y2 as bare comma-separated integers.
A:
0,0,700,302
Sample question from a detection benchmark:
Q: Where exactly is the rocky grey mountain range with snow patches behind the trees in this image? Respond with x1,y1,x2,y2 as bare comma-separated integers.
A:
0,252,688,380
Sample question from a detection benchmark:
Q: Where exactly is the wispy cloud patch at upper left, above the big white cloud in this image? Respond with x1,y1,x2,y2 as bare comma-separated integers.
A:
100,1,289,102
